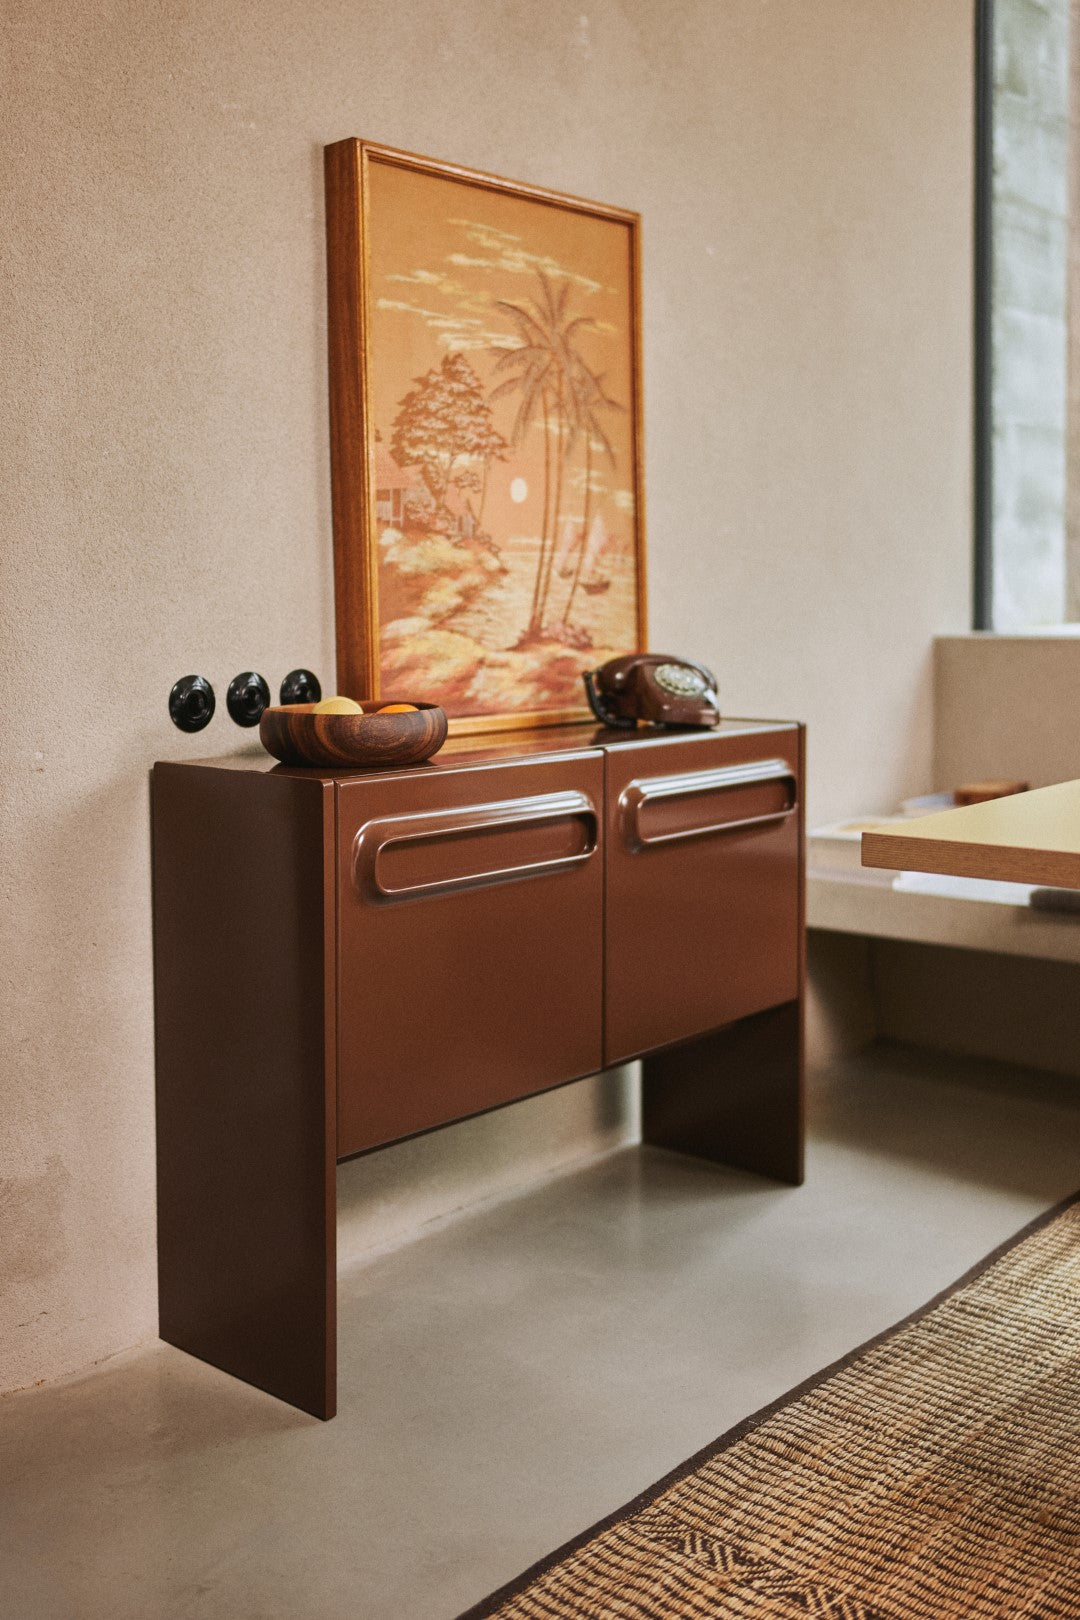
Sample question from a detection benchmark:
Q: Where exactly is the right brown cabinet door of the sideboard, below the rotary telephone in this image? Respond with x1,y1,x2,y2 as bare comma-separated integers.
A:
604,726,801,1064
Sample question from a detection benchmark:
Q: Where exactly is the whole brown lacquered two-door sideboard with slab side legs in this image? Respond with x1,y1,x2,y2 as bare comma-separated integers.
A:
152,721,805,1418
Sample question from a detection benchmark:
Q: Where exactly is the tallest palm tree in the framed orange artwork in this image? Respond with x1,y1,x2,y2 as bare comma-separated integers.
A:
491,271,594,643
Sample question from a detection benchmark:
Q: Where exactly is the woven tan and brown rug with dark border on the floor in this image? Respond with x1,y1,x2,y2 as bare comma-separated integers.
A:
461,1196,1080,1620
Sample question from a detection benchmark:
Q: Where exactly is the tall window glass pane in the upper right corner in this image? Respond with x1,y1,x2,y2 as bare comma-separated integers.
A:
983,0,1080,630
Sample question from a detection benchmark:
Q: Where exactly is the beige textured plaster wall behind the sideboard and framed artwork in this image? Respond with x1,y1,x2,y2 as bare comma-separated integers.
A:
0,0,972,1388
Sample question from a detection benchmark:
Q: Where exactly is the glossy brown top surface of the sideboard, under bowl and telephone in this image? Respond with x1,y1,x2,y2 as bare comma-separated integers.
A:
159,719,797,781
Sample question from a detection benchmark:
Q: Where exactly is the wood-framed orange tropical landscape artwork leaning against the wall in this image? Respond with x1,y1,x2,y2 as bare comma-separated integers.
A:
325,139,646,731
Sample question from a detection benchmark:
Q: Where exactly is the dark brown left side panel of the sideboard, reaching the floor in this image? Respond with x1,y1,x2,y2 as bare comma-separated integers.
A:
154,765,337,1418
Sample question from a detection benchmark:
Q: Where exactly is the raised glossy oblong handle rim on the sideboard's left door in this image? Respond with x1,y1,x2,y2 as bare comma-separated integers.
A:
353,791,597,901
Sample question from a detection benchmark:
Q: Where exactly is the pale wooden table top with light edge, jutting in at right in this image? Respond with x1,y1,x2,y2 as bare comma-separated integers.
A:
863,781,1080,889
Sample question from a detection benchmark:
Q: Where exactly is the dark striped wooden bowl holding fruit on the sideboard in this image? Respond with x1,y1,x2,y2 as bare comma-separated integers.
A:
259,698,447,768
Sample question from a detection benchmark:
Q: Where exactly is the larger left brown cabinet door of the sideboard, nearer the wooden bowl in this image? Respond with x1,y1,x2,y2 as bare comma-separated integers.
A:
337,750,604,1158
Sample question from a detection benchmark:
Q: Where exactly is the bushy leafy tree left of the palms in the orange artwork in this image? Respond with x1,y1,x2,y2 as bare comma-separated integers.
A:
390,353,508,514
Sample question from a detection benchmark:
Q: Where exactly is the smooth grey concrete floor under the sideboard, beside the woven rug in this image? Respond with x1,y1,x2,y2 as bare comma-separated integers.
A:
0,1048,1080,1620
